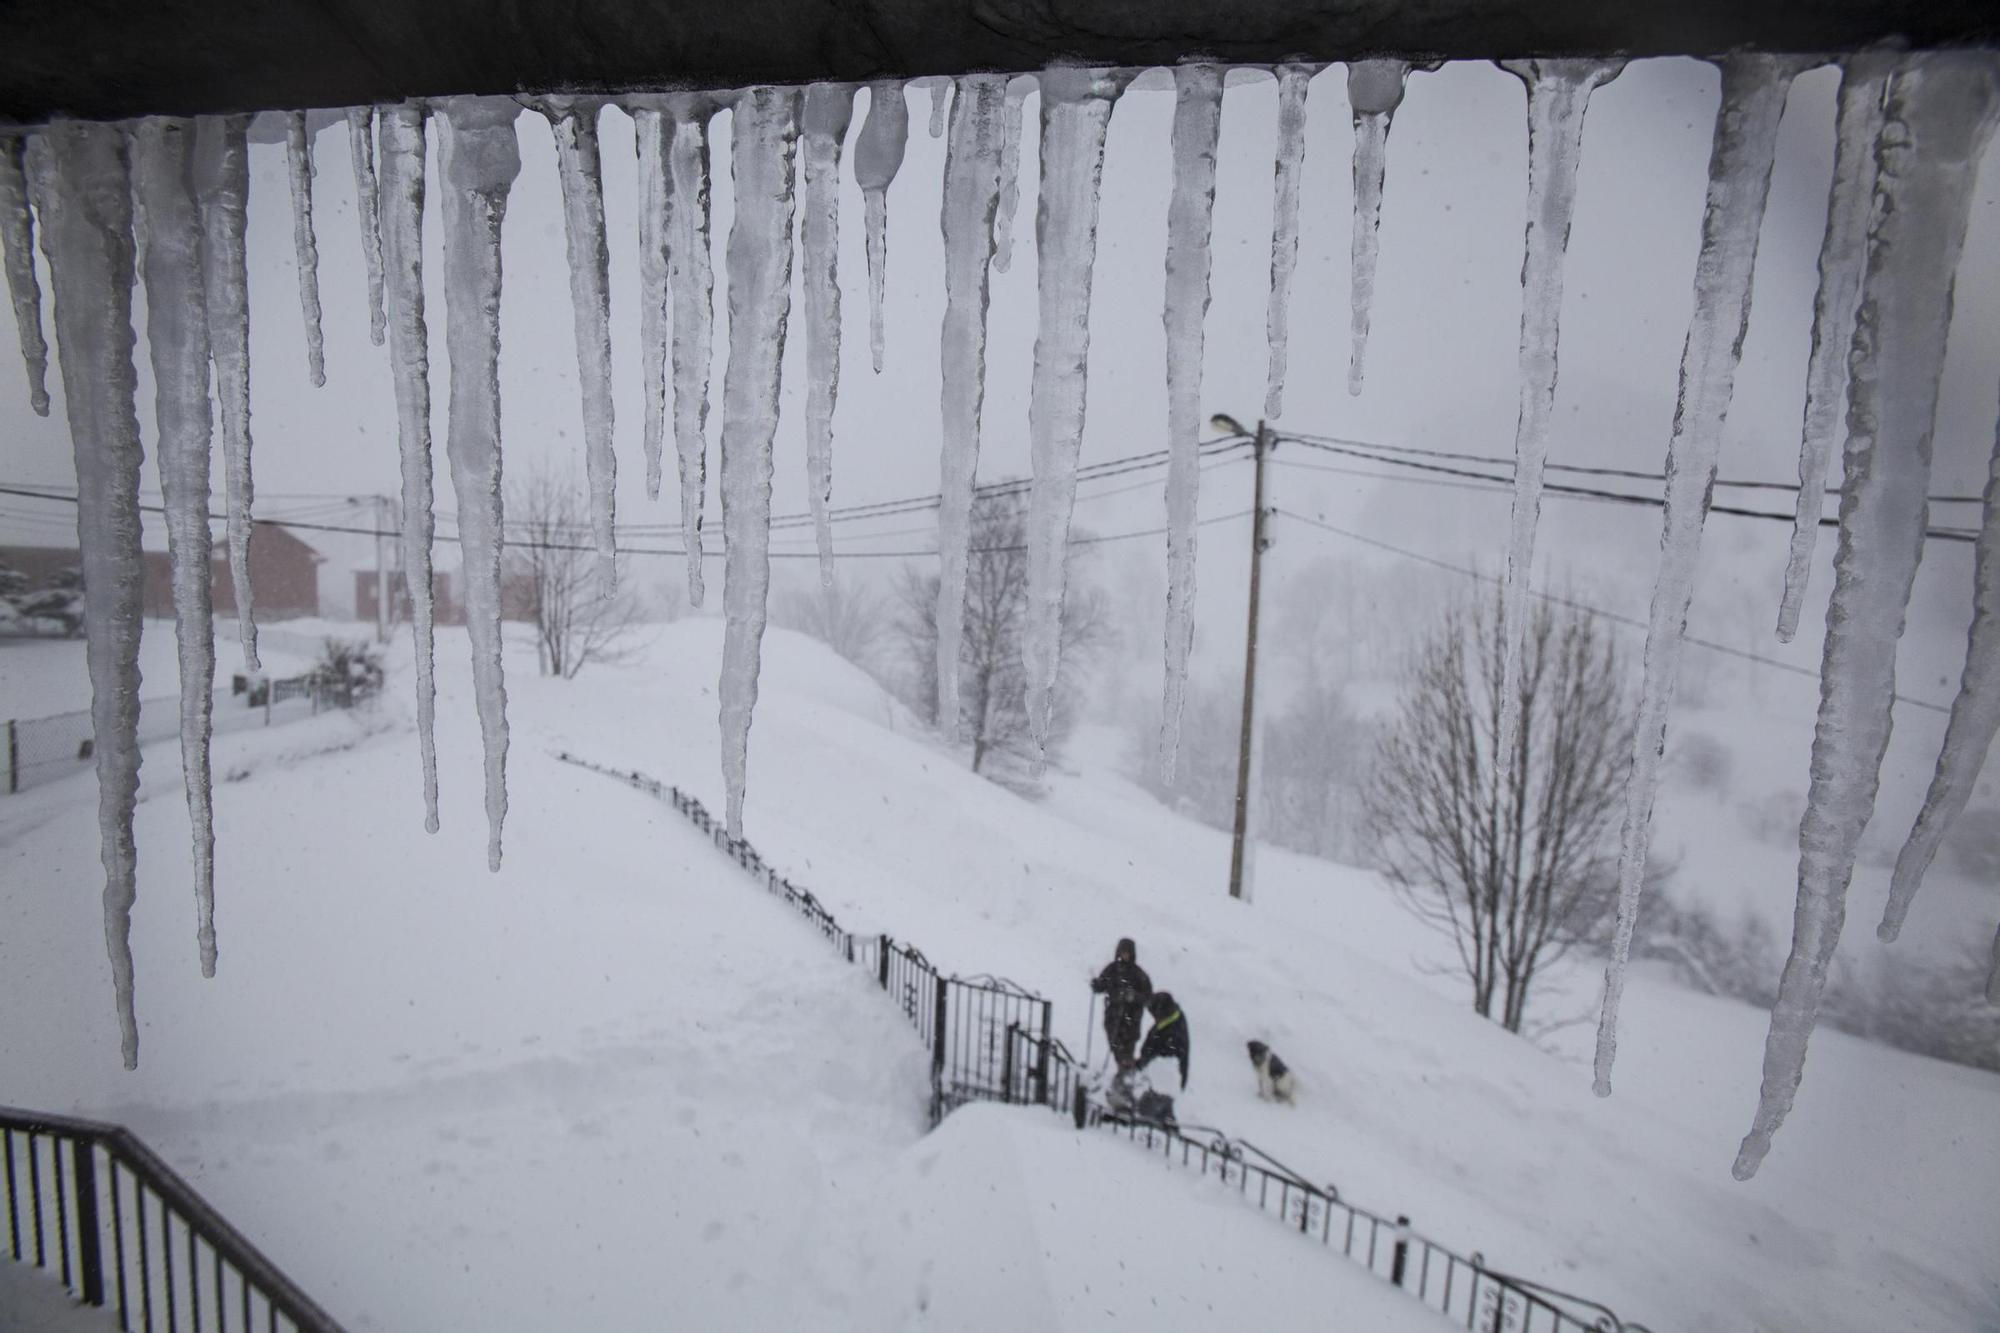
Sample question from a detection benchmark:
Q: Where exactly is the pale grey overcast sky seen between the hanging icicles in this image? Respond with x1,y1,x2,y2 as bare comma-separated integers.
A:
0,60,2000,712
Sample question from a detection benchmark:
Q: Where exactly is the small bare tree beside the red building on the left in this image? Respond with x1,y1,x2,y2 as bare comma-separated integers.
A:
506,468,638,681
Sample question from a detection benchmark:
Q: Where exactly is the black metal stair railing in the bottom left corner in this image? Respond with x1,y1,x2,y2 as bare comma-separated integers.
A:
0,1107,340,1333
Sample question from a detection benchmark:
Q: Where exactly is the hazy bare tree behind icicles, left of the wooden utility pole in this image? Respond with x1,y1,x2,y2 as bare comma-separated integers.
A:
896,490,1112,783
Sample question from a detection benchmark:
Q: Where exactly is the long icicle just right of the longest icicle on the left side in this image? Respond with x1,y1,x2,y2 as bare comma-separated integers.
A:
132,118,216,977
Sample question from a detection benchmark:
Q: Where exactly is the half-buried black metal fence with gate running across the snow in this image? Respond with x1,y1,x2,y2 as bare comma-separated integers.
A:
556,751,1646,1333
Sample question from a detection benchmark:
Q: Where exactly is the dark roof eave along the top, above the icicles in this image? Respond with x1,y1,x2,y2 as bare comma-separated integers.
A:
0,0,2000,122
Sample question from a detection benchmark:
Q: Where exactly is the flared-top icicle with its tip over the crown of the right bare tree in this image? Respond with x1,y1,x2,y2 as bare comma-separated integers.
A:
1496,60,1624,767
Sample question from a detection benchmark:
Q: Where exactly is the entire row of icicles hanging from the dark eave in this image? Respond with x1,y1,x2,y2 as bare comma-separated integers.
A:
0,52,2000,1177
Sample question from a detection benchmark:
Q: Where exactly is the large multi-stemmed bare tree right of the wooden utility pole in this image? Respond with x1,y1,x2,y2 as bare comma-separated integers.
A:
1366,588,1632,1033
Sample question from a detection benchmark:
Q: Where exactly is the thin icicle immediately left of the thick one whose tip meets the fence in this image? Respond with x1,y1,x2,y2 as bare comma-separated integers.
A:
668,94,718,606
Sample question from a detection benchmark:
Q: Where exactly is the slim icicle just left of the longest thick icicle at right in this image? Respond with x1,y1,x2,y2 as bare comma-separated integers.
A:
1778,54,1894,642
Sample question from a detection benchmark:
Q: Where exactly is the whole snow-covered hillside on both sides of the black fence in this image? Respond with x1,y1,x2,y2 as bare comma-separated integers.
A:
0,620,2000,1331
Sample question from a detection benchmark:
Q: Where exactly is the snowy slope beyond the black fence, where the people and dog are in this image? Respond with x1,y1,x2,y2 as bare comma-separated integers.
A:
504,620,2000,1329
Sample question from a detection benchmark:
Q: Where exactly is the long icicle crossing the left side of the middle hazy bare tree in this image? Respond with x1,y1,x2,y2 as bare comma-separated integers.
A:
938,74,1008,741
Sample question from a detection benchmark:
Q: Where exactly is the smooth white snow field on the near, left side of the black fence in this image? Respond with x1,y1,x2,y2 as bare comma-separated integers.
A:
0,624,1440,1331
